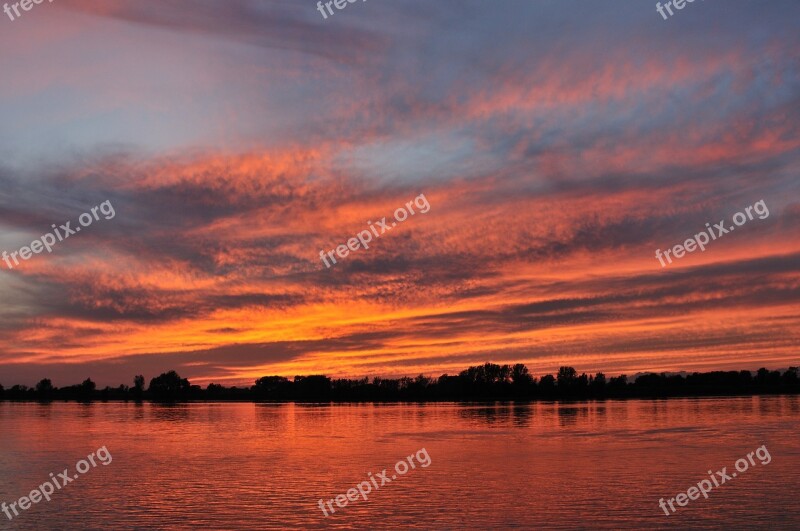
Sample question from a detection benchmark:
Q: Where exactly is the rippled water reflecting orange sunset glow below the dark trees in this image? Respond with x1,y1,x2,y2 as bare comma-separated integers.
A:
0,397,800,530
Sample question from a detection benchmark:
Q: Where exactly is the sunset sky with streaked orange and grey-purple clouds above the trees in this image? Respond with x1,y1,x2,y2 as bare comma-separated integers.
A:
0,0,800,386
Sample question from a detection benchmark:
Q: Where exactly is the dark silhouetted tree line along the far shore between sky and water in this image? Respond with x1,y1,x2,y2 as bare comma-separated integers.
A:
0,363,800,402
